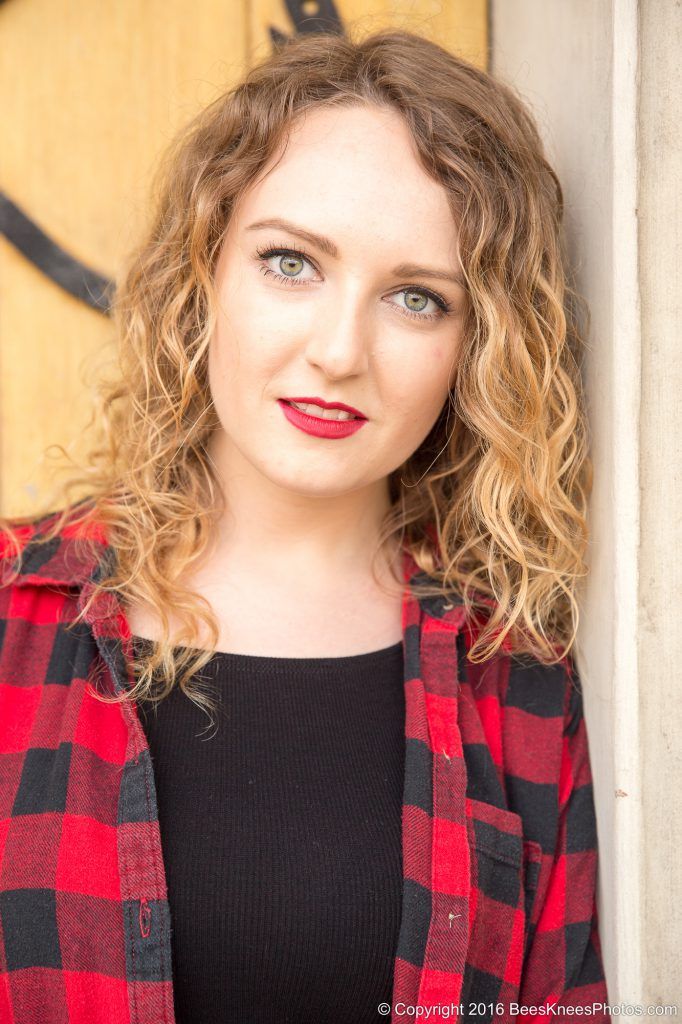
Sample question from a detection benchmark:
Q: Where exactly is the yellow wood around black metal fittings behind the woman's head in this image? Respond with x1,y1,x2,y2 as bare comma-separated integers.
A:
0,0,487,515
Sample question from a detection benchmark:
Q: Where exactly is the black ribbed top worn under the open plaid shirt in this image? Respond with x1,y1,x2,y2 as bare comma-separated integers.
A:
134,637,404,1024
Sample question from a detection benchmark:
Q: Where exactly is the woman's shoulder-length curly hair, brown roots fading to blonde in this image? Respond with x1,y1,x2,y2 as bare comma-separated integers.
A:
2,31,592,709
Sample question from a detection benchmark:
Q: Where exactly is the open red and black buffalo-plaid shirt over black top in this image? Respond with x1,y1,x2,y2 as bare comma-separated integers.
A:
0,507,611,1024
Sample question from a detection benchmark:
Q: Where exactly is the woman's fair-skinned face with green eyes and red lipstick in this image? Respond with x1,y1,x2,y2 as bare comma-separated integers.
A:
204,106,466,497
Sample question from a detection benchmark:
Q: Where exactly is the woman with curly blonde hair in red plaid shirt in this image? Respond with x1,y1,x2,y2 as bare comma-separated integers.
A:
0,24,610,1024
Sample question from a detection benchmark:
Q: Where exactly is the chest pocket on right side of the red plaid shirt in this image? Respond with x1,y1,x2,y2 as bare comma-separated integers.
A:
463,798,542,1003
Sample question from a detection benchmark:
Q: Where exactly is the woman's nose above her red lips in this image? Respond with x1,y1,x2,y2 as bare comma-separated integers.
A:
305,284,373,380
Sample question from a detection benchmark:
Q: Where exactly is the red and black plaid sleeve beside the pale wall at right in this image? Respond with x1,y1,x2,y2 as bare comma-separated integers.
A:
519,658,611,1021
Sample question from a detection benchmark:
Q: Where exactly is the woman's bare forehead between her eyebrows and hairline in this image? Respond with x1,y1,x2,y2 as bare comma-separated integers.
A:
235,104,456,259
